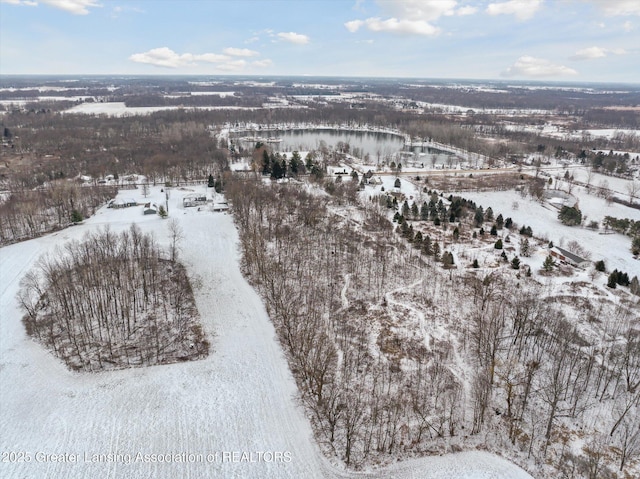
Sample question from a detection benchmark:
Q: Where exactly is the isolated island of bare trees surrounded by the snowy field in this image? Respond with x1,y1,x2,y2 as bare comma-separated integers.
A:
19,225,209,371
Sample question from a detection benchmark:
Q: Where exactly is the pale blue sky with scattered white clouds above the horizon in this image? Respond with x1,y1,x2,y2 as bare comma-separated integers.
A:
0,0,640,83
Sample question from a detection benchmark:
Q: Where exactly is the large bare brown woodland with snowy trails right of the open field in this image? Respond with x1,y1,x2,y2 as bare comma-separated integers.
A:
227,176,640,471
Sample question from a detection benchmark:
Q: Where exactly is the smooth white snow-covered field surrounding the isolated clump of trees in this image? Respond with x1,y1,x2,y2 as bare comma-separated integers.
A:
0,189,535,479
